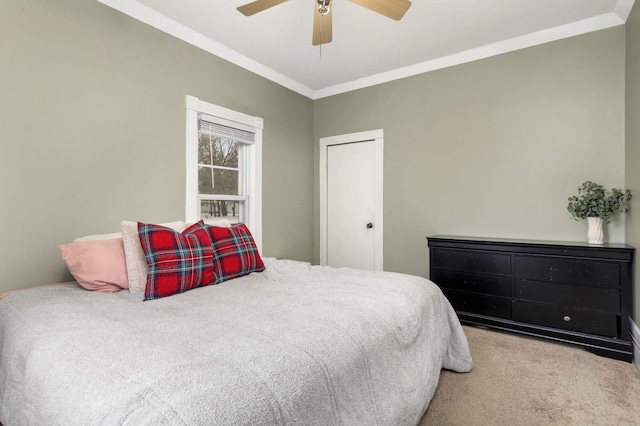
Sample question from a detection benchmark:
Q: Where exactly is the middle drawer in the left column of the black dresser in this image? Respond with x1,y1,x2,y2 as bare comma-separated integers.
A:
430,269,511,297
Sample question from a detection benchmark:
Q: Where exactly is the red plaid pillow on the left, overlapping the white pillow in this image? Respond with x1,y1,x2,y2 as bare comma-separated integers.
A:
138,221,215,300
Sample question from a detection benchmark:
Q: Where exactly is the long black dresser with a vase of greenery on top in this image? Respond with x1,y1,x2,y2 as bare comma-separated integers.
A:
427,235,634,362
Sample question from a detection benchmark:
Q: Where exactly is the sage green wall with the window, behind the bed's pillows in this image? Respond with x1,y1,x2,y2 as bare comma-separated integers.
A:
0,0,314,292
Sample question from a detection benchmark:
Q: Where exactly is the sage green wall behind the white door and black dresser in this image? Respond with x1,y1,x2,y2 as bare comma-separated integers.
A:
314,27,625,276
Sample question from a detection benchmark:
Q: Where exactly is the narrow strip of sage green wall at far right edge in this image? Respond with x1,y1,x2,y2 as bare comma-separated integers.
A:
625,3,640,324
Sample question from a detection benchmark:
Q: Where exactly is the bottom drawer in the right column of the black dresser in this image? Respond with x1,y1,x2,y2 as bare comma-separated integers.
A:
513,301,618,337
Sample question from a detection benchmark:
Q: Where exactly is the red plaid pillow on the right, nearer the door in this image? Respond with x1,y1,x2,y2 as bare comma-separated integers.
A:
209,223,264,284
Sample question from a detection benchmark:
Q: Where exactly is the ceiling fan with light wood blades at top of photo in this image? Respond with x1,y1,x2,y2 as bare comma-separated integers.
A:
238,0,411,46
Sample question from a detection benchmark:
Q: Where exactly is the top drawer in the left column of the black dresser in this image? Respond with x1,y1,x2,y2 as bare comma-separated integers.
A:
431,249,511,275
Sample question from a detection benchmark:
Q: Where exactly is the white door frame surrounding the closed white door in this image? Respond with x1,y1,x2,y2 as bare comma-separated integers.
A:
320,129,384,271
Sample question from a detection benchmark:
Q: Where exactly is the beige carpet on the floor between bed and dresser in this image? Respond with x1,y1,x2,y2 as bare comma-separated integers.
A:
420,326,640,426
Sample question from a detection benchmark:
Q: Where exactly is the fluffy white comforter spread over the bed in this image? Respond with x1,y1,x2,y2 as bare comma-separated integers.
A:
0,259,472,426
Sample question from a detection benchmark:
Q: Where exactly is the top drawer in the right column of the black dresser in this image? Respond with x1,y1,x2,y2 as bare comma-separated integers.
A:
514,256,620,287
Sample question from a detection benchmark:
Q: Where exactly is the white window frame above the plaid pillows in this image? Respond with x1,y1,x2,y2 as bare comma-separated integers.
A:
185,96,264,252
